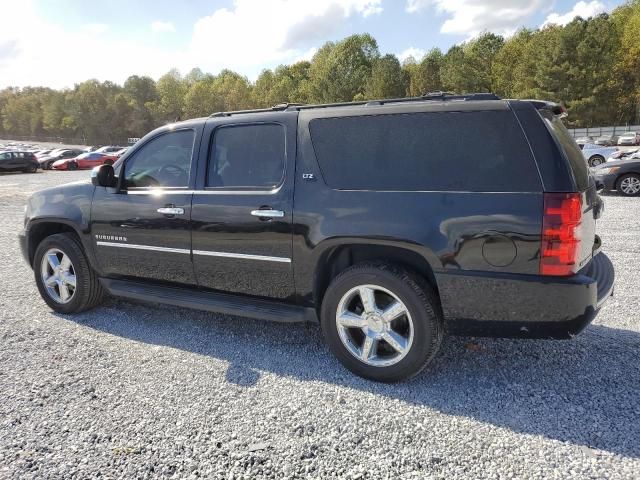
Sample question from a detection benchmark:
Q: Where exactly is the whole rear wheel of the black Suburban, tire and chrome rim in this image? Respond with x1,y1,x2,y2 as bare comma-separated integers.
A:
321,264,443,382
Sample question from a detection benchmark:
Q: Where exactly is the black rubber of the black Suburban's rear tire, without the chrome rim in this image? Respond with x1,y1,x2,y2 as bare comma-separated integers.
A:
321,263,443,383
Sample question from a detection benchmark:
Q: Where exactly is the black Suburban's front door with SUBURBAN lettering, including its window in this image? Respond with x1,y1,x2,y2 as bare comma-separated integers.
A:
91,129,199,285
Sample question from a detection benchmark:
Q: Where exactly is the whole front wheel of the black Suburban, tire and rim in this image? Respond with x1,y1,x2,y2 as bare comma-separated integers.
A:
33,233,104,313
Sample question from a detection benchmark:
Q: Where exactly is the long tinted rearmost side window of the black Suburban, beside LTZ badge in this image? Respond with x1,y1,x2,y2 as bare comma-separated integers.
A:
310,111,541,192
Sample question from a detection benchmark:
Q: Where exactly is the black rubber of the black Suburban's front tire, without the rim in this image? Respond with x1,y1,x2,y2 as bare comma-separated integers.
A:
33,233,104,313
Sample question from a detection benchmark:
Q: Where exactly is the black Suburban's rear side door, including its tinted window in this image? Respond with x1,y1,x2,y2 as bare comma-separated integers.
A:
192,112,297,299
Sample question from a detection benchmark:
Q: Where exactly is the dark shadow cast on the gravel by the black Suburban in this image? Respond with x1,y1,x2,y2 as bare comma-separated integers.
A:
62,300,640,458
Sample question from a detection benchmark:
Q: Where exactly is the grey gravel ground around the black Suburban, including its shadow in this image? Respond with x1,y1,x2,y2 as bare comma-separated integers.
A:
0,172,640,480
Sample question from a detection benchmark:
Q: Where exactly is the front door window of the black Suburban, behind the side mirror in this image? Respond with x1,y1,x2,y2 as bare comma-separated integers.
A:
125,130,195,188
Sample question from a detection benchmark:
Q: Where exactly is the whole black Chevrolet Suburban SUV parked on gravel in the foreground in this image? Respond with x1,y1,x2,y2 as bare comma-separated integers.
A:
21,94,614,381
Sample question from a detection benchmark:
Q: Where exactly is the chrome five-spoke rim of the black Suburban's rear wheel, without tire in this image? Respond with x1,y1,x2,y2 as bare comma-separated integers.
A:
336,285,414,367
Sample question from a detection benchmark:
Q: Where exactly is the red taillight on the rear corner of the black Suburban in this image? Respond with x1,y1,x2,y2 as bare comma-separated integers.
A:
540,193,582,276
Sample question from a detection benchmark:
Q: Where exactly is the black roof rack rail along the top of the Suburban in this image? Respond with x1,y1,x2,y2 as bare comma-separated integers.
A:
210,91,501,117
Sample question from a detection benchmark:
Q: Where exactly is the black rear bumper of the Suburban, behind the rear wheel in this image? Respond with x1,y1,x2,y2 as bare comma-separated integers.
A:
436,253,615,339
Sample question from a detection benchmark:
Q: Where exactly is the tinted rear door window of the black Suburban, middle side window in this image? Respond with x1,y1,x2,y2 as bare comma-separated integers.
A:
207,124,286,188
